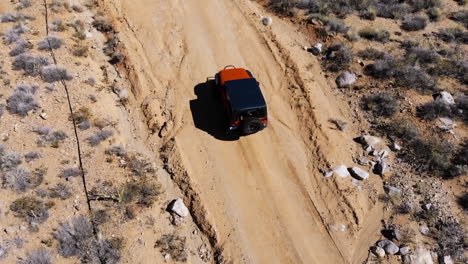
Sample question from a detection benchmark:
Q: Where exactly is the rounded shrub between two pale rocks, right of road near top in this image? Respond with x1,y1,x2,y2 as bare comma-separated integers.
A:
325,43,353,72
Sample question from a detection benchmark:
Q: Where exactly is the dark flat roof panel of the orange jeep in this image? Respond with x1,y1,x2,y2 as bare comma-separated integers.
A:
225,78,266,111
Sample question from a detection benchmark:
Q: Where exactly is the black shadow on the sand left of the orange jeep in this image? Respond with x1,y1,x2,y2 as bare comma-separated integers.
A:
190,80,239,141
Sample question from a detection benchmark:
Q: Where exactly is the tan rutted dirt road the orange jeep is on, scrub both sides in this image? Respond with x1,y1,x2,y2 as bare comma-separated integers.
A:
102,0,380,263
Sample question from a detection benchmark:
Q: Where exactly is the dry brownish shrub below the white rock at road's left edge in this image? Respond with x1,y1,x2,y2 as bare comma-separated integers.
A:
155,234,188,262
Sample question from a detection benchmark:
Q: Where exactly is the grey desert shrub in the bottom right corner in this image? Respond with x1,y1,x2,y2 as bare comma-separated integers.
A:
434,220,466,259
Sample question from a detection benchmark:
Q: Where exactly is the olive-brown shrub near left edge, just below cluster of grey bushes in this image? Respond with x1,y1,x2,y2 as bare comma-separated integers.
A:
10,196,51,223
